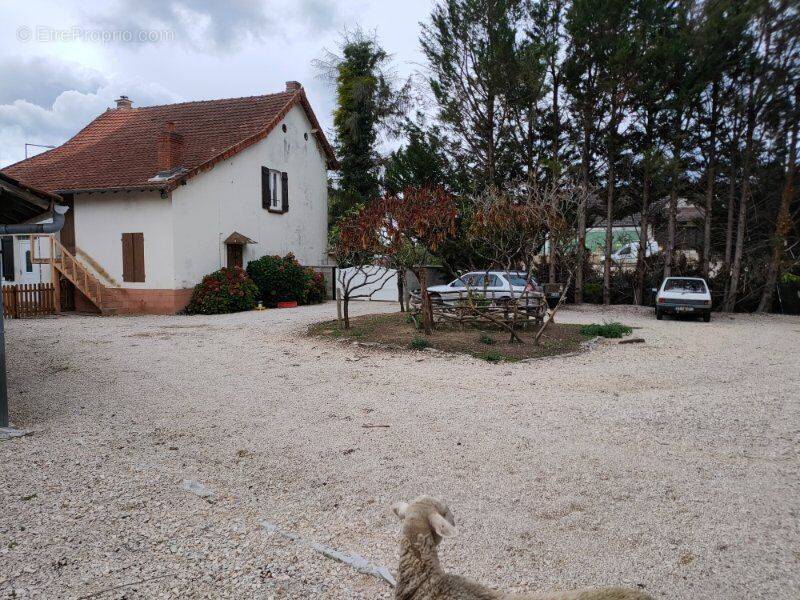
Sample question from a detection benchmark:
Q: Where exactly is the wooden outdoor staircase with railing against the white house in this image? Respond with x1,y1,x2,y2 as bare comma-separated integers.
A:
31,234,117,315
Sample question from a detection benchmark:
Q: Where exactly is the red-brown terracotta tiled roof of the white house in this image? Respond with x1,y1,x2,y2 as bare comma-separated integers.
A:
3,88,336,192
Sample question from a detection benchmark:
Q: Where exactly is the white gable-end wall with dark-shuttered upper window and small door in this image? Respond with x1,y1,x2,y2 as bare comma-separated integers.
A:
172,106,328,288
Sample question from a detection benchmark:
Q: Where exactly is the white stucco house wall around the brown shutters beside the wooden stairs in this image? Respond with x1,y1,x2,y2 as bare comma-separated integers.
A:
73,192,176,289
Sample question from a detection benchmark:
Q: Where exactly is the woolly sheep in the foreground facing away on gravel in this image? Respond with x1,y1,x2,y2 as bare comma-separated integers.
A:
392,496,652,600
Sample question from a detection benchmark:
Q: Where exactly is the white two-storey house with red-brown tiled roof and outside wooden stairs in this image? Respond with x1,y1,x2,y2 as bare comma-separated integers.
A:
3,81,336,313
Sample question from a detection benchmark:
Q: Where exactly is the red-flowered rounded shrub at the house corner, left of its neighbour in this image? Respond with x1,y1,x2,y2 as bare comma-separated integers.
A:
186,267,258,315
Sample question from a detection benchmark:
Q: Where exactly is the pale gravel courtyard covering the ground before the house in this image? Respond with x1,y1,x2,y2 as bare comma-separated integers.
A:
0,303,800,600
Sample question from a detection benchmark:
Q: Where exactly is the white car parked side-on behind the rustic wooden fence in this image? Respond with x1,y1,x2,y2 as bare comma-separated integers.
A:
428,271,538,304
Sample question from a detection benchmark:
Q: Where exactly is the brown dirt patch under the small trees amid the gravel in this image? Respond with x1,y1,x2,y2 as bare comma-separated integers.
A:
309,313,589,362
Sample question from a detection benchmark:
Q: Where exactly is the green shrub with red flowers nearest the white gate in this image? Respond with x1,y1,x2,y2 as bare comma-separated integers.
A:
247,252,312,306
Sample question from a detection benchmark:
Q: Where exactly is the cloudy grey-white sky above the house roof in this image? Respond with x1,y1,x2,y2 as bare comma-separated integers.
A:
0,0,432,167
